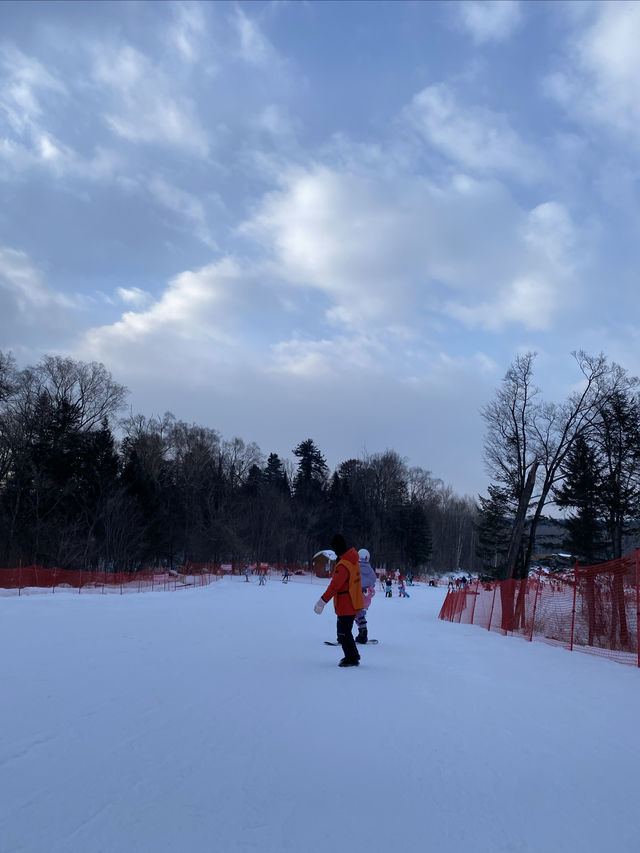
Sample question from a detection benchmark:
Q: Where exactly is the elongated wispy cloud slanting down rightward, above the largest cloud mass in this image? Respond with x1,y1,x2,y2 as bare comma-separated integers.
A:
405,83,542,181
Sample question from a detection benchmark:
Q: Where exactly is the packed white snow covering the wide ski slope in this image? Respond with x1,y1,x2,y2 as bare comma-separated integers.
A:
0,577,640,853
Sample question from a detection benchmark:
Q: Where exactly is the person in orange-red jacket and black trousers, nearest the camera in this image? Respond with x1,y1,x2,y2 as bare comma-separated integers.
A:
313,533,363,666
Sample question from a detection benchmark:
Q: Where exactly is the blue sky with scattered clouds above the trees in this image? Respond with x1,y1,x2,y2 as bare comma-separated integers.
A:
0,0,640,495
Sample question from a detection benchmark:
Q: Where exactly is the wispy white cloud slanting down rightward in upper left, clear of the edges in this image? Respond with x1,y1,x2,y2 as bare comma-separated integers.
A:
93,45,209,157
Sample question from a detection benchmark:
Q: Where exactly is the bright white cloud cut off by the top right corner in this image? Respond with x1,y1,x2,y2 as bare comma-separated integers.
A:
545,3,640,143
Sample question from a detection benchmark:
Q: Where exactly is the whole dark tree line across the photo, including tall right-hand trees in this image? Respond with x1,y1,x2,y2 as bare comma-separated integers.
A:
6,351,640,578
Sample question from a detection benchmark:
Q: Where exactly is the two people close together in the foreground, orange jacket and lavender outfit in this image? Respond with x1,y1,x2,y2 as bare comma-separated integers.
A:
313,533,376,667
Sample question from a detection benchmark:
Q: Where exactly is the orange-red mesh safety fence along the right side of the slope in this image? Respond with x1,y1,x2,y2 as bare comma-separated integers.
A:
440,549,640,667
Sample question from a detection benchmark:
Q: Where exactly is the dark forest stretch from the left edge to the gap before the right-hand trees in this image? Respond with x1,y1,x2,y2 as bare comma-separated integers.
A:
0,353,479,573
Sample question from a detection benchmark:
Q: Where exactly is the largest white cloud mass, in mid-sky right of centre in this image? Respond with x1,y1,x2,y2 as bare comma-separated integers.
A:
241,158,578,334
